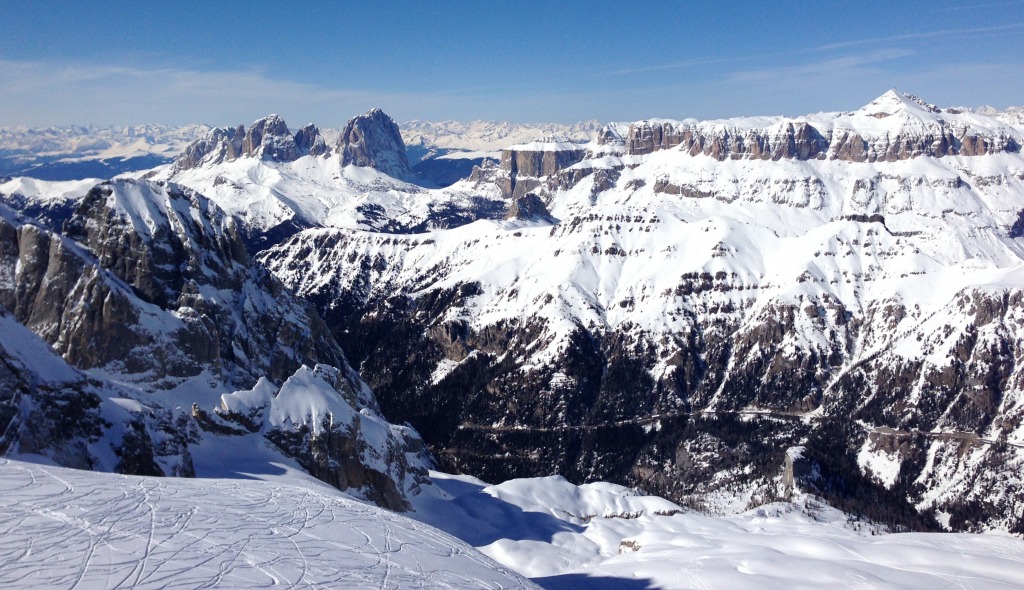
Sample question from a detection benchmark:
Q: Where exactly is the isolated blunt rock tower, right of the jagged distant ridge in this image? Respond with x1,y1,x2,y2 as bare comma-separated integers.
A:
338,109,414,179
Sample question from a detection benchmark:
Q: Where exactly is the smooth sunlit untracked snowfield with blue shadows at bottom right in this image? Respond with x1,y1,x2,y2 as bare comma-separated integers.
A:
413,472,1024,590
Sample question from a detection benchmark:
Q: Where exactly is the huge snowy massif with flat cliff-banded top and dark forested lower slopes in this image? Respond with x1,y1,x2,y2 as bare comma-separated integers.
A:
253,91,1024,531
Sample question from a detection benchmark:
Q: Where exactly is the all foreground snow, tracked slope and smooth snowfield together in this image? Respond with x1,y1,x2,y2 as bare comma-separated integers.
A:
0,459,1024,589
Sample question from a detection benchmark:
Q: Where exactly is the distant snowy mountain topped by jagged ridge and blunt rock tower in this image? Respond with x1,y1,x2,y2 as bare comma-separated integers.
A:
145,110,506,249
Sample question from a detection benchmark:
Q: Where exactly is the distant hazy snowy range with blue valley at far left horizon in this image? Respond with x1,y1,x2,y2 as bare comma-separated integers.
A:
0,125,210,180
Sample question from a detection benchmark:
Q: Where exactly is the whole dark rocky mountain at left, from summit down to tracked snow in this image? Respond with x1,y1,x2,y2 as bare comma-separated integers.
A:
0,179,432,510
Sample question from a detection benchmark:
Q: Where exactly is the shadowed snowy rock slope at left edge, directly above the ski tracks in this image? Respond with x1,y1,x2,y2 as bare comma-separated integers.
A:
0,306,198,477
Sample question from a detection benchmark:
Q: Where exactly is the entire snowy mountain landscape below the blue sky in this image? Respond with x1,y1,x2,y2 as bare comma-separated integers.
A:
0,90,1024,588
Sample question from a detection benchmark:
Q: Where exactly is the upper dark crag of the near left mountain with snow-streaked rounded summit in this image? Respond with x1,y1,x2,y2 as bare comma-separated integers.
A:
0,180,345,385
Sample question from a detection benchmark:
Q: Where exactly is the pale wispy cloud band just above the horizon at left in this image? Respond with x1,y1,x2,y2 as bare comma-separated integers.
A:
0,59,505,126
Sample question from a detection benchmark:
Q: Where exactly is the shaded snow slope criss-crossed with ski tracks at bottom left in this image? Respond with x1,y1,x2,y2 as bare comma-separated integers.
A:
0,459,536,589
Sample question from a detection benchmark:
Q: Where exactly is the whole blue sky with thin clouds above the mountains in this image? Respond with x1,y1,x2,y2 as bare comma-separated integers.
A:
0,0,1024,126
